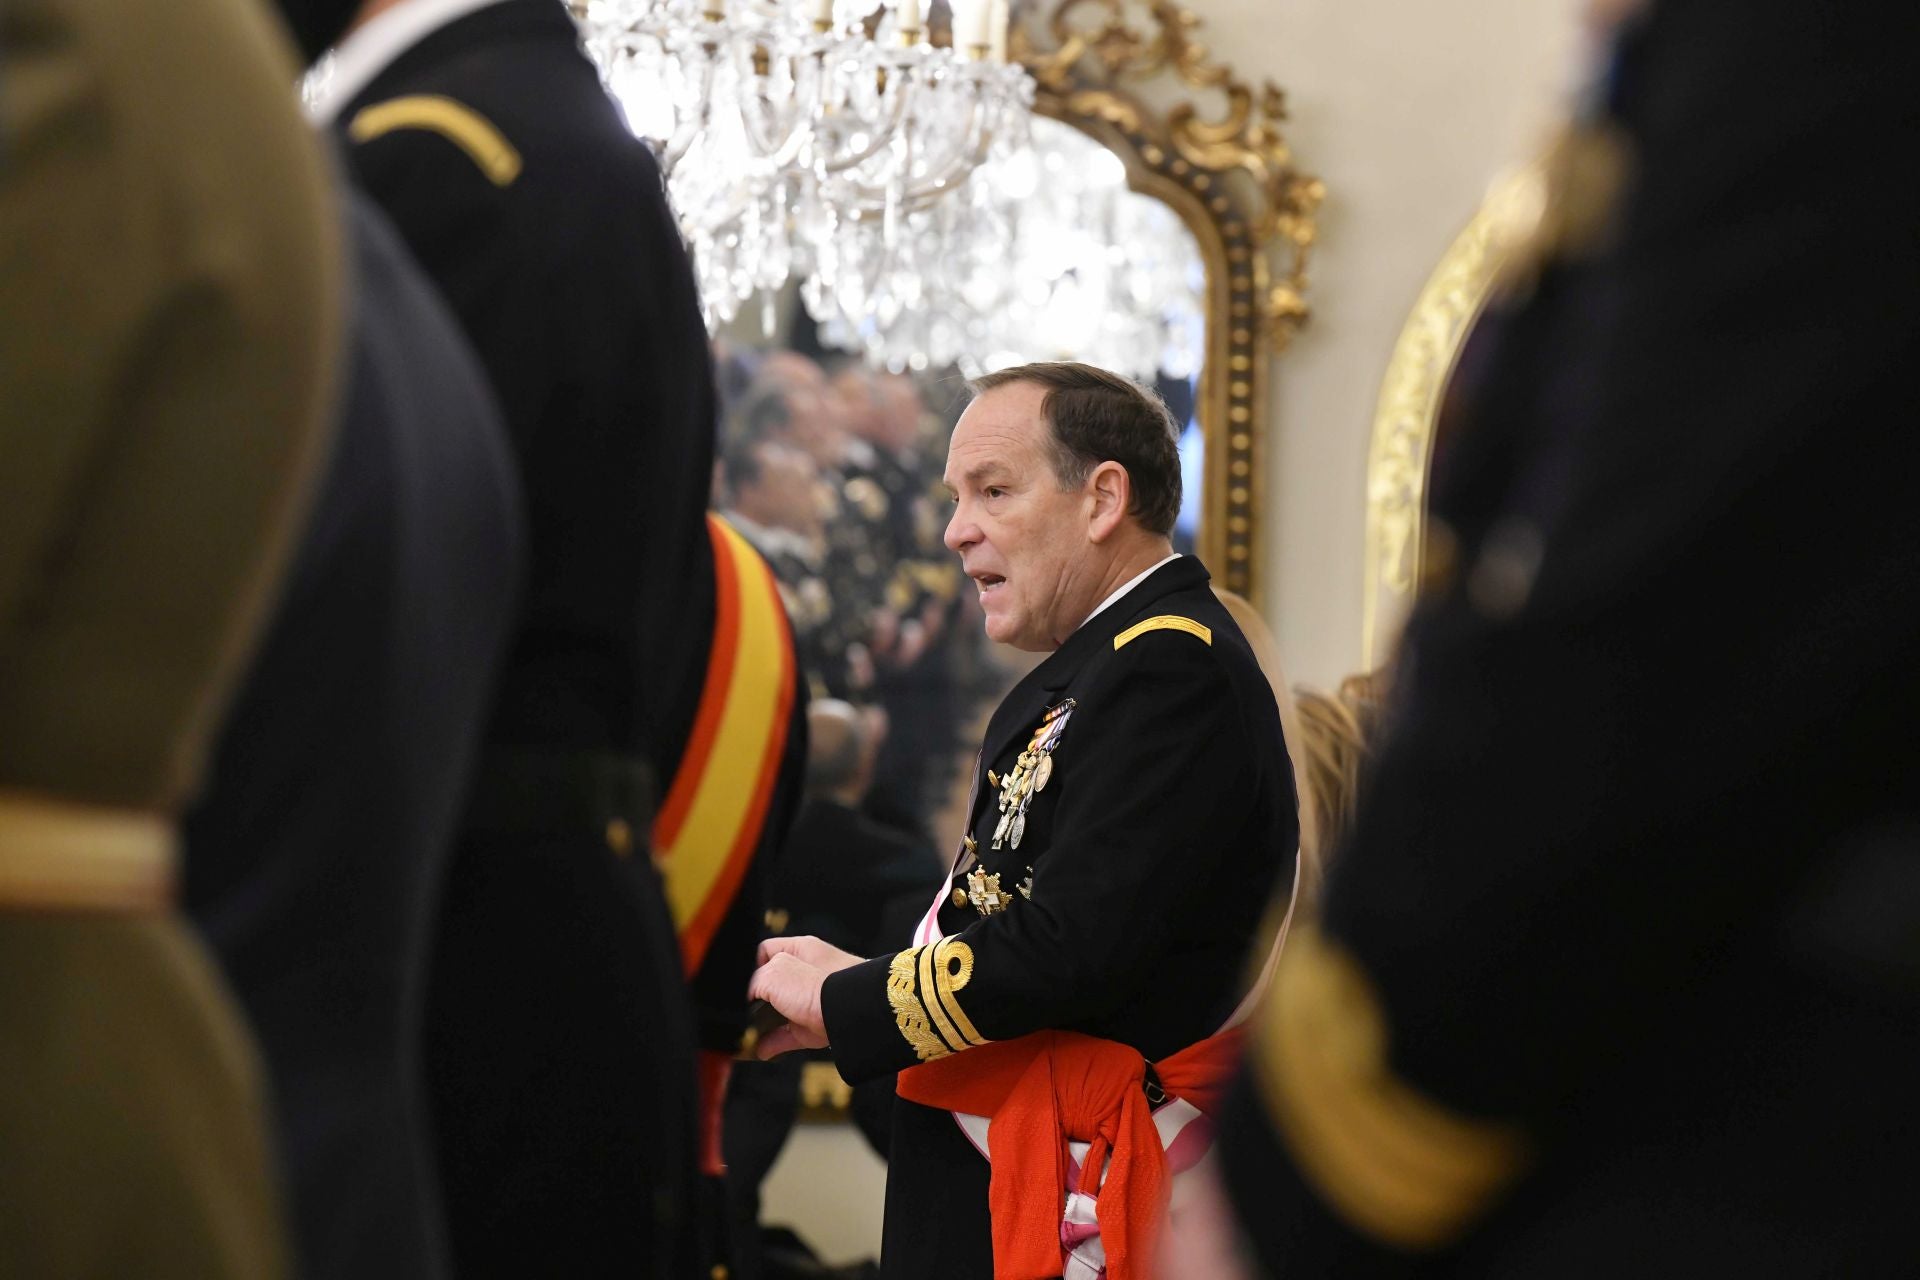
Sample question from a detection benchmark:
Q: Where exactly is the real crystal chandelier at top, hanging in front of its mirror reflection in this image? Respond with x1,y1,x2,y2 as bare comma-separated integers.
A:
574,0,1033,326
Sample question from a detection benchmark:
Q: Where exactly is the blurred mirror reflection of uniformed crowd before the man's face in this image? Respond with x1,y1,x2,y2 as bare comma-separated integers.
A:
714,340,1006,842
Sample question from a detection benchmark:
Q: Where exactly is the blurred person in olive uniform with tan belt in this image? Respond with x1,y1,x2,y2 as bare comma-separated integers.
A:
0,0,342,1280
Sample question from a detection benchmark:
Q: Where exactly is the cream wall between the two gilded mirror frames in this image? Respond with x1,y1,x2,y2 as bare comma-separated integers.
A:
1221,0,1578,685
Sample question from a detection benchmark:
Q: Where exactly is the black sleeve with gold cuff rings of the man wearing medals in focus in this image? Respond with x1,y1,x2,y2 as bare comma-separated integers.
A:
822,631,1269,1082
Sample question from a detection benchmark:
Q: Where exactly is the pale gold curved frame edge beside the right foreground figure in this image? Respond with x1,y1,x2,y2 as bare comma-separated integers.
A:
1361,169,1542,670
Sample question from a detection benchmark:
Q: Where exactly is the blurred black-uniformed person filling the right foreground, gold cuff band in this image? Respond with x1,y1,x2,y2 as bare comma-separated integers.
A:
1165,0,1920,1276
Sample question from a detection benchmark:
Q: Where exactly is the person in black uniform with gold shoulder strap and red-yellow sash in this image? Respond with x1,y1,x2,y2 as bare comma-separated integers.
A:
297,0,804,1278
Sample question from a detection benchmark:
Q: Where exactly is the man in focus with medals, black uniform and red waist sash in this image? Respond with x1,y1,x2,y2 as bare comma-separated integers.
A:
753,365,1298,1280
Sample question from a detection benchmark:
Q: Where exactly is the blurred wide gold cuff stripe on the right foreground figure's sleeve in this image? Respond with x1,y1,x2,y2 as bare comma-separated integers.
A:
1254,927,1526,1249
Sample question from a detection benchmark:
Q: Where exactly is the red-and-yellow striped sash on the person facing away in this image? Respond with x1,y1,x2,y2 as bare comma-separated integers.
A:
653,512,795,973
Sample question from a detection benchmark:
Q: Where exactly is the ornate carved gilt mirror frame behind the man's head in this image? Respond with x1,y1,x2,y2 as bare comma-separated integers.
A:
1010,0,1325,603
